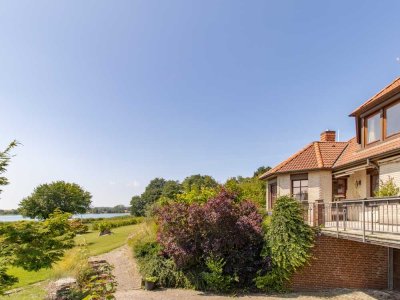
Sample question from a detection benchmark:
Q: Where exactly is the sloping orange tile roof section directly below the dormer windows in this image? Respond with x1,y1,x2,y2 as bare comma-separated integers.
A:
333,137,400,169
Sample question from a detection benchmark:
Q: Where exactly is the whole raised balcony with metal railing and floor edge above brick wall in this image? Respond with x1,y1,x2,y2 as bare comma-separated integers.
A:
303,197,400,248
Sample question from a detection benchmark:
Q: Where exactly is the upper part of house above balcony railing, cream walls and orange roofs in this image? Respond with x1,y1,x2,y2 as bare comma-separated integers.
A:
260,78,400,211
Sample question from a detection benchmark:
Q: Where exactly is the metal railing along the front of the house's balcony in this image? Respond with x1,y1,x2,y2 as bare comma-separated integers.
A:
303,197,400,240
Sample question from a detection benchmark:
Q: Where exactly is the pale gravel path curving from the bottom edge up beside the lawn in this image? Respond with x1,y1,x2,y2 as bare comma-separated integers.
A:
92,245,400,300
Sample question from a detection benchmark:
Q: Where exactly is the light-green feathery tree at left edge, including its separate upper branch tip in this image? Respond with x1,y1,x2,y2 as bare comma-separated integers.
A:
0,141,74,294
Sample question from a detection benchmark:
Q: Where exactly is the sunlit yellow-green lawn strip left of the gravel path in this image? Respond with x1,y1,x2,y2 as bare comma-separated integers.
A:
4,224,140,290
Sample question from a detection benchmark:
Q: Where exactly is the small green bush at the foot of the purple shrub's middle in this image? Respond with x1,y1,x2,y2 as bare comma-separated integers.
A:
201,258,235,293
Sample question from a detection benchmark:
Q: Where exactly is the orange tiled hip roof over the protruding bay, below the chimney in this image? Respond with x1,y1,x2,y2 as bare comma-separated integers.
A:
260,142,347,179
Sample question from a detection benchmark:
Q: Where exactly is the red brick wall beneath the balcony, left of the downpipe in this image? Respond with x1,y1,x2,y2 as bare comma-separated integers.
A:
291,236,388,291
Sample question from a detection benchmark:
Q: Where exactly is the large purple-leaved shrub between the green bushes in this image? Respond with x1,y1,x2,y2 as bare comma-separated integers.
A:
157,189,270,287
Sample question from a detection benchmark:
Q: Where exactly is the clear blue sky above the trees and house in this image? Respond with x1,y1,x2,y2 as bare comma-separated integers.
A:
0,0,400,208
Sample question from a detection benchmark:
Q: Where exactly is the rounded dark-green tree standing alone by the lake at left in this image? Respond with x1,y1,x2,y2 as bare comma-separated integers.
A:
19,181,92,219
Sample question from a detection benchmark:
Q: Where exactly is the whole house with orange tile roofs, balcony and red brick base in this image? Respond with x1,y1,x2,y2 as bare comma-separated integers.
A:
260,78,400,289
